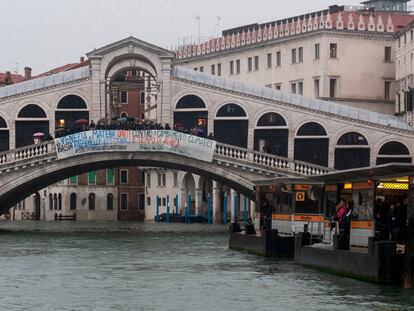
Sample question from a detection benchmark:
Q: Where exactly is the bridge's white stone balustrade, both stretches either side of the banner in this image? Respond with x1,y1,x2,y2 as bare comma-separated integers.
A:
0,137,330,176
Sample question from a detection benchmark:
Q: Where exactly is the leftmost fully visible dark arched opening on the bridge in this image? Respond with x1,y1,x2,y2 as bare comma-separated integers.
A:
16,104,49,148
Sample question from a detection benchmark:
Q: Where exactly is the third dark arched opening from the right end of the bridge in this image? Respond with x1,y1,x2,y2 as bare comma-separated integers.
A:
295,122,329,166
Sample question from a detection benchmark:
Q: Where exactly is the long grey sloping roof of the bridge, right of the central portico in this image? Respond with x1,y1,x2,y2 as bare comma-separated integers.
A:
172,67,414,131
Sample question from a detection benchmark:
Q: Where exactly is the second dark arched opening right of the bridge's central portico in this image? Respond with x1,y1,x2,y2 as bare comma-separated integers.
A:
214,104,249,148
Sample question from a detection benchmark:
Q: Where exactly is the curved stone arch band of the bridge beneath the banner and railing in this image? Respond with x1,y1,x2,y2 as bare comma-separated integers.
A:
0,152,254,211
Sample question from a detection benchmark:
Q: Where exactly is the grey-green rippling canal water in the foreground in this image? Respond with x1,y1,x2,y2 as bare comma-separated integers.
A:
0,224,414,311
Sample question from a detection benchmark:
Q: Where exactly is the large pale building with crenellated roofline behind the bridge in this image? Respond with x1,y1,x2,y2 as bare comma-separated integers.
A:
176,6,414,114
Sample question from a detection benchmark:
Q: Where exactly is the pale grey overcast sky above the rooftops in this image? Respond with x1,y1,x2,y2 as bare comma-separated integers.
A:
0,0,410,75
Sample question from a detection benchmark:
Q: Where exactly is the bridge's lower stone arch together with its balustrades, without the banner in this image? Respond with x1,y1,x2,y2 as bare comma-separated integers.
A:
0,136,329,212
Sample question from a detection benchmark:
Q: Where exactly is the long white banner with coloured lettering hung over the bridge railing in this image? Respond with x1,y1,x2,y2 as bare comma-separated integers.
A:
55,130,216,162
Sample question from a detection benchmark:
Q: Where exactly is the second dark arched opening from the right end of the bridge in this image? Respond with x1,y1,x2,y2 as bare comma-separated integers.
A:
335,132,370,170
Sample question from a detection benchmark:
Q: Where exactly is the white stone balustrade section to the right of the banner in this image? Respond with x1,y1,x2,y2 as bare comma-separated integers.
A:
215,143,331,176
